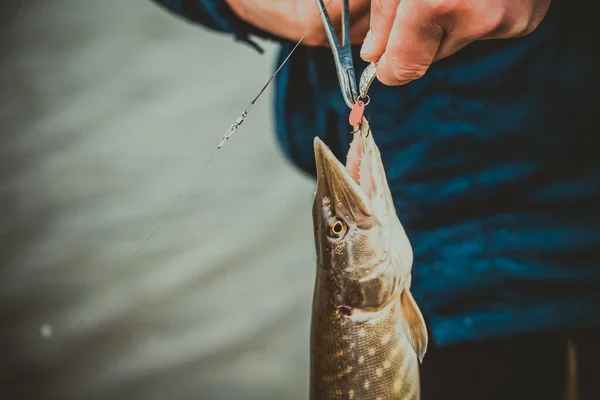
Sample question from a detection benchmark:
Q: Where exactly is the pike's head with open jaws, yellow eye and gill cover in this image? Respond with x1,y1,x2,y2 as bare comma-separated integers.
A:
313,119,413,310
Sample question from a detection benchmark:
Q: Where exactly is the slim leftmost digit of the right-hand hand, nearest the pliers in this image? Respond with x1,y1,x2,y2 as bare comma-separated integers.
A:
360,0,400,61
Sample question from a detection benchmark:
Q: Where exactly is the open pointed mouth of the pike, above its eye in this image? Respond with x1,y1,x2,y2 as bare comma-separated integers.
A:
314,126,374,218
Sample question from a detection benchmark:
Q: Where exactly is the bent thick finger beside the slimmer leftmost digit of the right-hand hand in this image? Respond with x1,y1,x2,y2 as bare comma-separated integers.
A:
377,0,444,86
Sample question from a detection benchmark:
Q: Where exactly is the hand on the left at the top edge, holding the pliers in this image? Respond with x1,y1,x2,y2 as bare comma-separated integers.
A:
225,0,371,46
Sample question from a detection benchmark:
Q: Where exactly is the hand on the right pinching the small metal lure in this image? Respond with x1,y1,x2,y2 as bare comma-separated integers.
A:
361,0,551,86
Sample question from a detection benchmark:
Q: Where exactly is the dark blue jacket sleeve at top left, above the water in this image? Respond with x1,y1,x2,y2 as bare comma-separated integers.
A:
150,0,284,53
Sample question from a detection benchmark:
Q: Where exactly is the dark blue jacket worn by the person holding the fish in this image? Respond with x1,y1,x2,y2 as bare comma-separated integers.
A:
154,0,600,345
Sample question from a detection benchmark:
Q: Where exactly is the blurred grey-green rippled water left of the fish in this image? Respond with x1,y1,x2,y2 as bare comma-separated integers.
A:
0,0,315,400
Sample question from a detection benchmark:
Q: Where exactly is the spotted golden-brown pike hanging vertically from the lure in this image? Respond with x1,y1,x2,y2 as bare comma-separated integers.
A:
309,116,428,400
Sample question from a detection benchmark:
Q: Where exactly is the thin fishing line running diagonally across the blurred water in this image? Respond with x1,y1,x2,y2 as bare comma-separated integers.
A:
75,0,333,330
